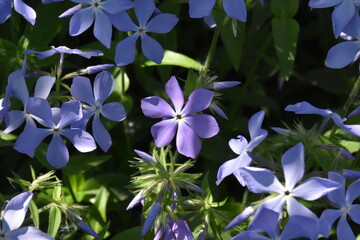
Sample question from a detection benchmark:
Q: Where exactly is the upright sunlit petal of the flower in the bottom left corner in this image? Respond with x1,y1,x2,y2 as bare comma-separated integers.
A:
2,192,33,233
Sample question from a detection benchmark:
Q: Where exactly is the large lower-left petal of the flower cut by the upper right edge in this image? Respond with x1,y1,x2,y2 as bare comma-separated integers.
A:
325,41,360,69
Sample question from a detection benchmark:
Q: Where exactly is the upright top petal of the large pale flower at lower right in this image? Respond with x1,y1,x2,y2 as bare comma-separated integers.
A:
281,143,305,190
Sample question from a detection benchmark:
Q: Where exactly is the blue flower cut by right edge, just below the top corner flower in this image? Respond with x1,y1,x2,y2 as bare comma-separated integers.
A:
325,14,360,69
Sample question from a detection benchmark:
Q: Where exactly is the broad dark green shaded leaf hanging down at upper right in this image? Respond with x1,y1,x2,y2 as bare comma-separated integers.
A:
272,17,300,80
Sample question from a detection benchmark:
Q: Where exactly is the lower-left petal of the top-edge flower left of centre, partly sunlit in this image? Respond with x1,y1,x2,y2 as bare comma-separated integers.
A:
69,7,95,36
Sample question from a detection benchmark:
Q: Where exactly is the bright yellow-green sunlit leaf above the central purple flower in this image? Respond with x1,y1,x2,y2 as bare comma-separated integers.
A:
141,50,204,70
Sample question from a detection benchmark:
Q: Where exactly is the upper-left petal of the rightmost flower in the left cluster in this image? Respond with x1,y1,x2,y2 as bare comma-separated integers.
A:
71,76,95,106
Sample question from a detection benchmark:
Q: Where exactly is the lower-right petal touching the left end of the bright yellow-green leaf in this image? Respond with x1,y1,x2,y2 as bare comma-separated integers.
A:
141,34,164,64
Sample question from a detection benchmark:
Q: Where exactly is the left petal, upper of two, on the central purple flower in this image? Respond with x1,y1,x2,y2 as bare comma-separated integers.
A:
141,96,176,118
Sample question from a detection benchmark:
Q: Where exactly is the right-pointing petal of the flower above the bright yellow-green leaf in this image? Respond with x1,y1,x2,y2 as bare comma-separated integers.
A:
146,13,179,33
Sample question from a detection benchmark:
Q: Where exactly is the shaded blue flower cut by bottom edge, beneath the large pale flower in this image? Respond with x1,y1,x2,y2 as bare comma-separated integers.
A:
231,208,319,240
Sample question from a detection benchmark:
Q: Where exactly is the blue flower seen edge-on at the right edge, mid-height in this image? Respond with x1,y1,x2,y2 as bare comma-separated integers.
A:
285,101,360,136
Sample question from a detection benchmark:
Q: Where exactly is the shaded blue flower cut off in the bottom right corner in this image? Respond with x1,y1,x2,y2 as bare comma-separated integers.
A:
320,172,360,240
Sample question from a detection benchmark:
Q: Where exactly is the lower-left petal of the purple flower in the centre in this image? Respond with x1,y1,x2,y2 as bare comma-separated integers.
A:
151,119,178,147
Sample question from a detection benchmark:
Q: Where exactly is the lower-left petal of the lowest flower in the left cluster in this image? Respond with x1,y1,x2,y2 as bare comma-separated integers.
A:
14,128,51,157
